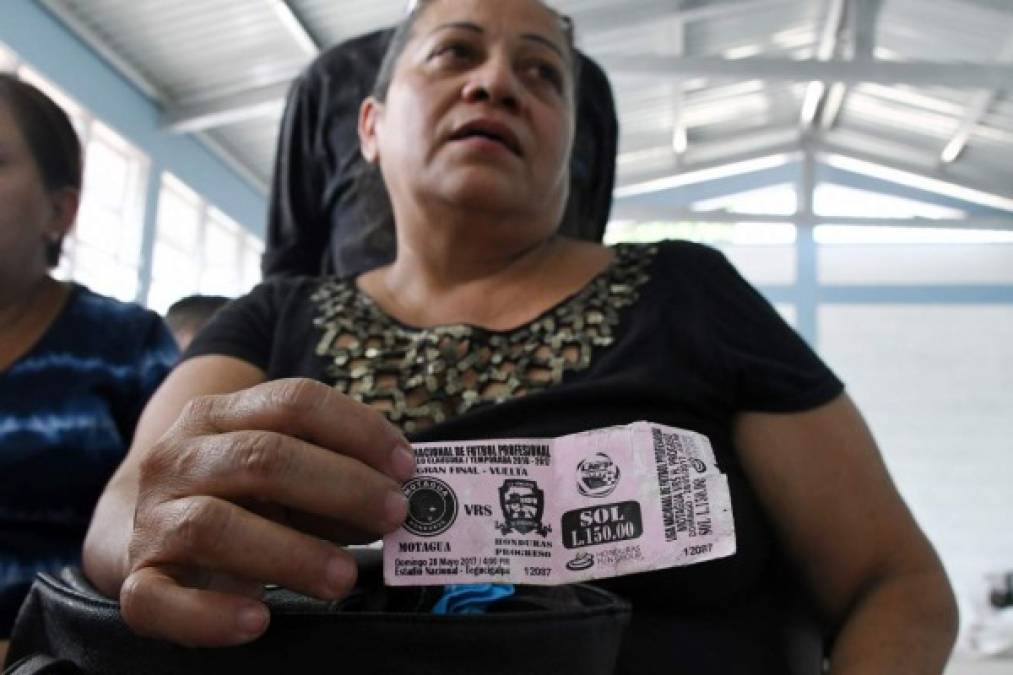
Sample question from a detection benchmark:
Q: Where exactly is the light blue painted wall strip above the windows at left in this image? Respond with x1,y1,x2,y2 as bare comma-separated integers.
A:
0,0,266,235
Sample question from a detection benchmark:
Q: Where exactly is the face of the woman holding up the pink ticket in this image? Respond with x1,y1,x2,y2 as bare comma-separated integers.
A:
361,0,574,225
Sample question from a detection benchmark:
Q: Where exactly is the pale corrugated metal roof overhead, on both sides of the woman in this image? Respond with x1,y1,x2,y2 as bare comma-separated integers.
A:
35,0,1013,203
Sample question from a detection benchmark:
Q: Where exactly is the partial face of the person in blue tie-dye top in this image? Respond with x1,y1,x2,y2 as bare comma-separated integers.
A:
0,101,69,283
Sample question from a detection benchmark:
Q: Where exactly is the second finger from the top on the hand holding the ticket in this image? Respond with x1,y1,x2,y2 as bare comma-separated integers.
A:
142,431,407,534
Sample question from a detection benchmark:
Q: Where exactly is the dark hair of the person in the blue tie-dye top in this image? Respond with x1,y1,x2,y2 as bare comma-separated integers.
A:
0,73,84,268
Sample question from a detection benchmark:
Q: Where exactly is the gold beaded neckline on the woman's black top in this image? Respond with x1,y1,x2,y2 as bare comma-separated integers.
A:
311,245,656,432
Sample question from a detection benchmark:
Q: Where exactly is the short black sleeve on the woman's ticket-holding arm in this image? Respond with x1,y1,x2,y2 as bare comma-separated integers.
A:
180,280,293,372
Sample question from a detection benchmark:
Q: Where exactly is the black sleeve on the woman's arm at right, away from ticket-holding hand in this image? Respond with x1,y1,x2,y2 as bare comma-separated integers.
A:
694,246,844,413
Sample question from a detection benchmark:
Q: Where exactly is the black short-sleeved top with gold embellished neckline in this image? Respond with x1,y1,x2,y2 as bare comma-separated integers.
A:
185,242,843,675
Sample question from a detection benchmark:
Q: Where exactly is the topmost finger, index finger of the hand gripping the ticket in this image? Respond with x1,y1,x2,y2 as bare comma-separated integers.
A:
180,379,415,481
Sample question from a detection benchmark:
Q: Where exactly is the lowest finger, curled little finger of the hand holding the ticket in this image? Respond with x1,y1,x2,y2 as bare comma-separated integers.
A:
120,568,270,647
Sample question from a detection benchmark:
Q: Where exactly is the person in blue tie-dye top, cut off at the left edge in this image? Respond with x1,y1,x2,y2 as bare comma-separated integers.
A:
0,74,177,644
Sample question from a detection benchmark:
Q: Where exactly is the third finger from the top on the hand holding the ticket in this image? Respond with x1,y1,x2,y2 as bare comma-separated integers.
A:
132,497,356,599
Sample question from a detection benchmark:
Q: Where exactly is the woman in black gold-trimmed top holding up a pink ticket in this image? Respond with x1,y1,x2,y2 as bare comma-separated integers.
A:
85,0,955,675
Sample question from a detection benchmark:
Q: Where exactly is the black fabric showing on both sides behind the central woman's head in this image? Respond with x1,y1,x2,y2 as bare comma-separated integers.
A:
261,28,619,278
